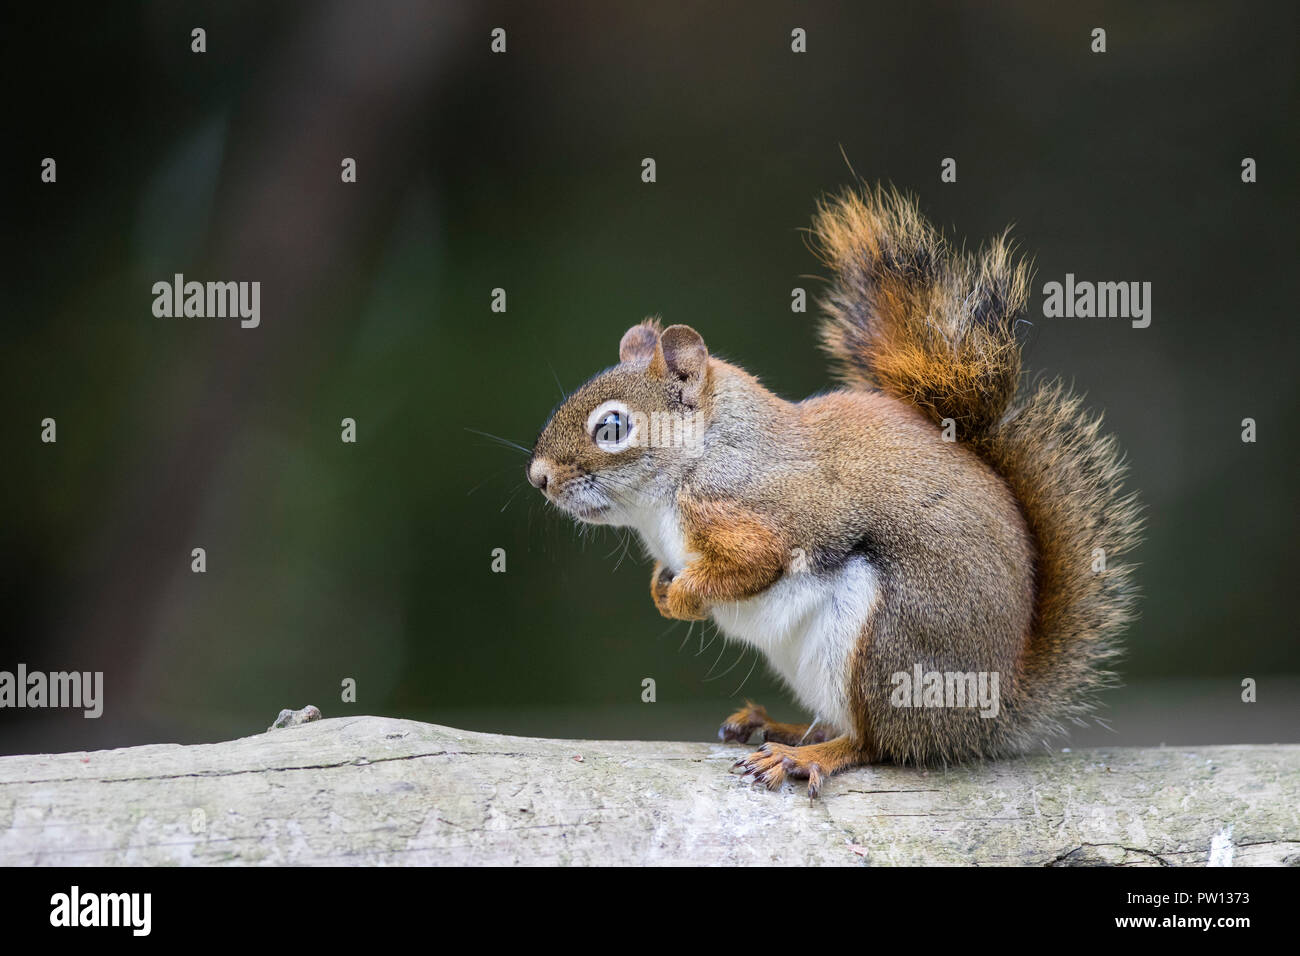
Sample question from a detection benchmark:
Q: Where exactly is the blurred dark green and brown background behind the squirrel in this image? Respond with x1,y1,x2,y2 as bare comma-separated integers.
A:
0,3,1300,752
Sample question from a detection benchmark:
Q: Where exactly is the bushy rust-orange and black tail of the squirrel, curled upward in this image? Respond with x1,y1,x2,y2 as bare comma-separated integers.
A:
813,189,1141,739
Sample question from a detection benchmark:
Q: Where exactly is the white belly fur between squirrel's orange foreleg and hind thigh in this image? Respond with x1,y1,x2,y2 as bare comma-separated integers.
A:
712,557,879,731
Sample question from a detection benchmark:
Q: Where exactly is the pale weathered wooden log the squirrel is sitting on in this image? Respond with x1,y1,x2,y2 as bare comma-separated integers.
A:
0,717,1300,866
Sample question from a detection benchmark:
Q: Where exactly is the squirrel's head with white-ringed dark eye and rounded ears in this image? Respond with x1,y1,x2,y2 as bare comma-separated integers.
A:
528,319,712,524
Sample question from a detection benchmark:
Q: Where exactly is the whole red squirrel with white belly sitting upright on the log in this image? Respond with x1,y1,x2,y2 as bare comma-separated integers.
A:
528,187,1141,797
